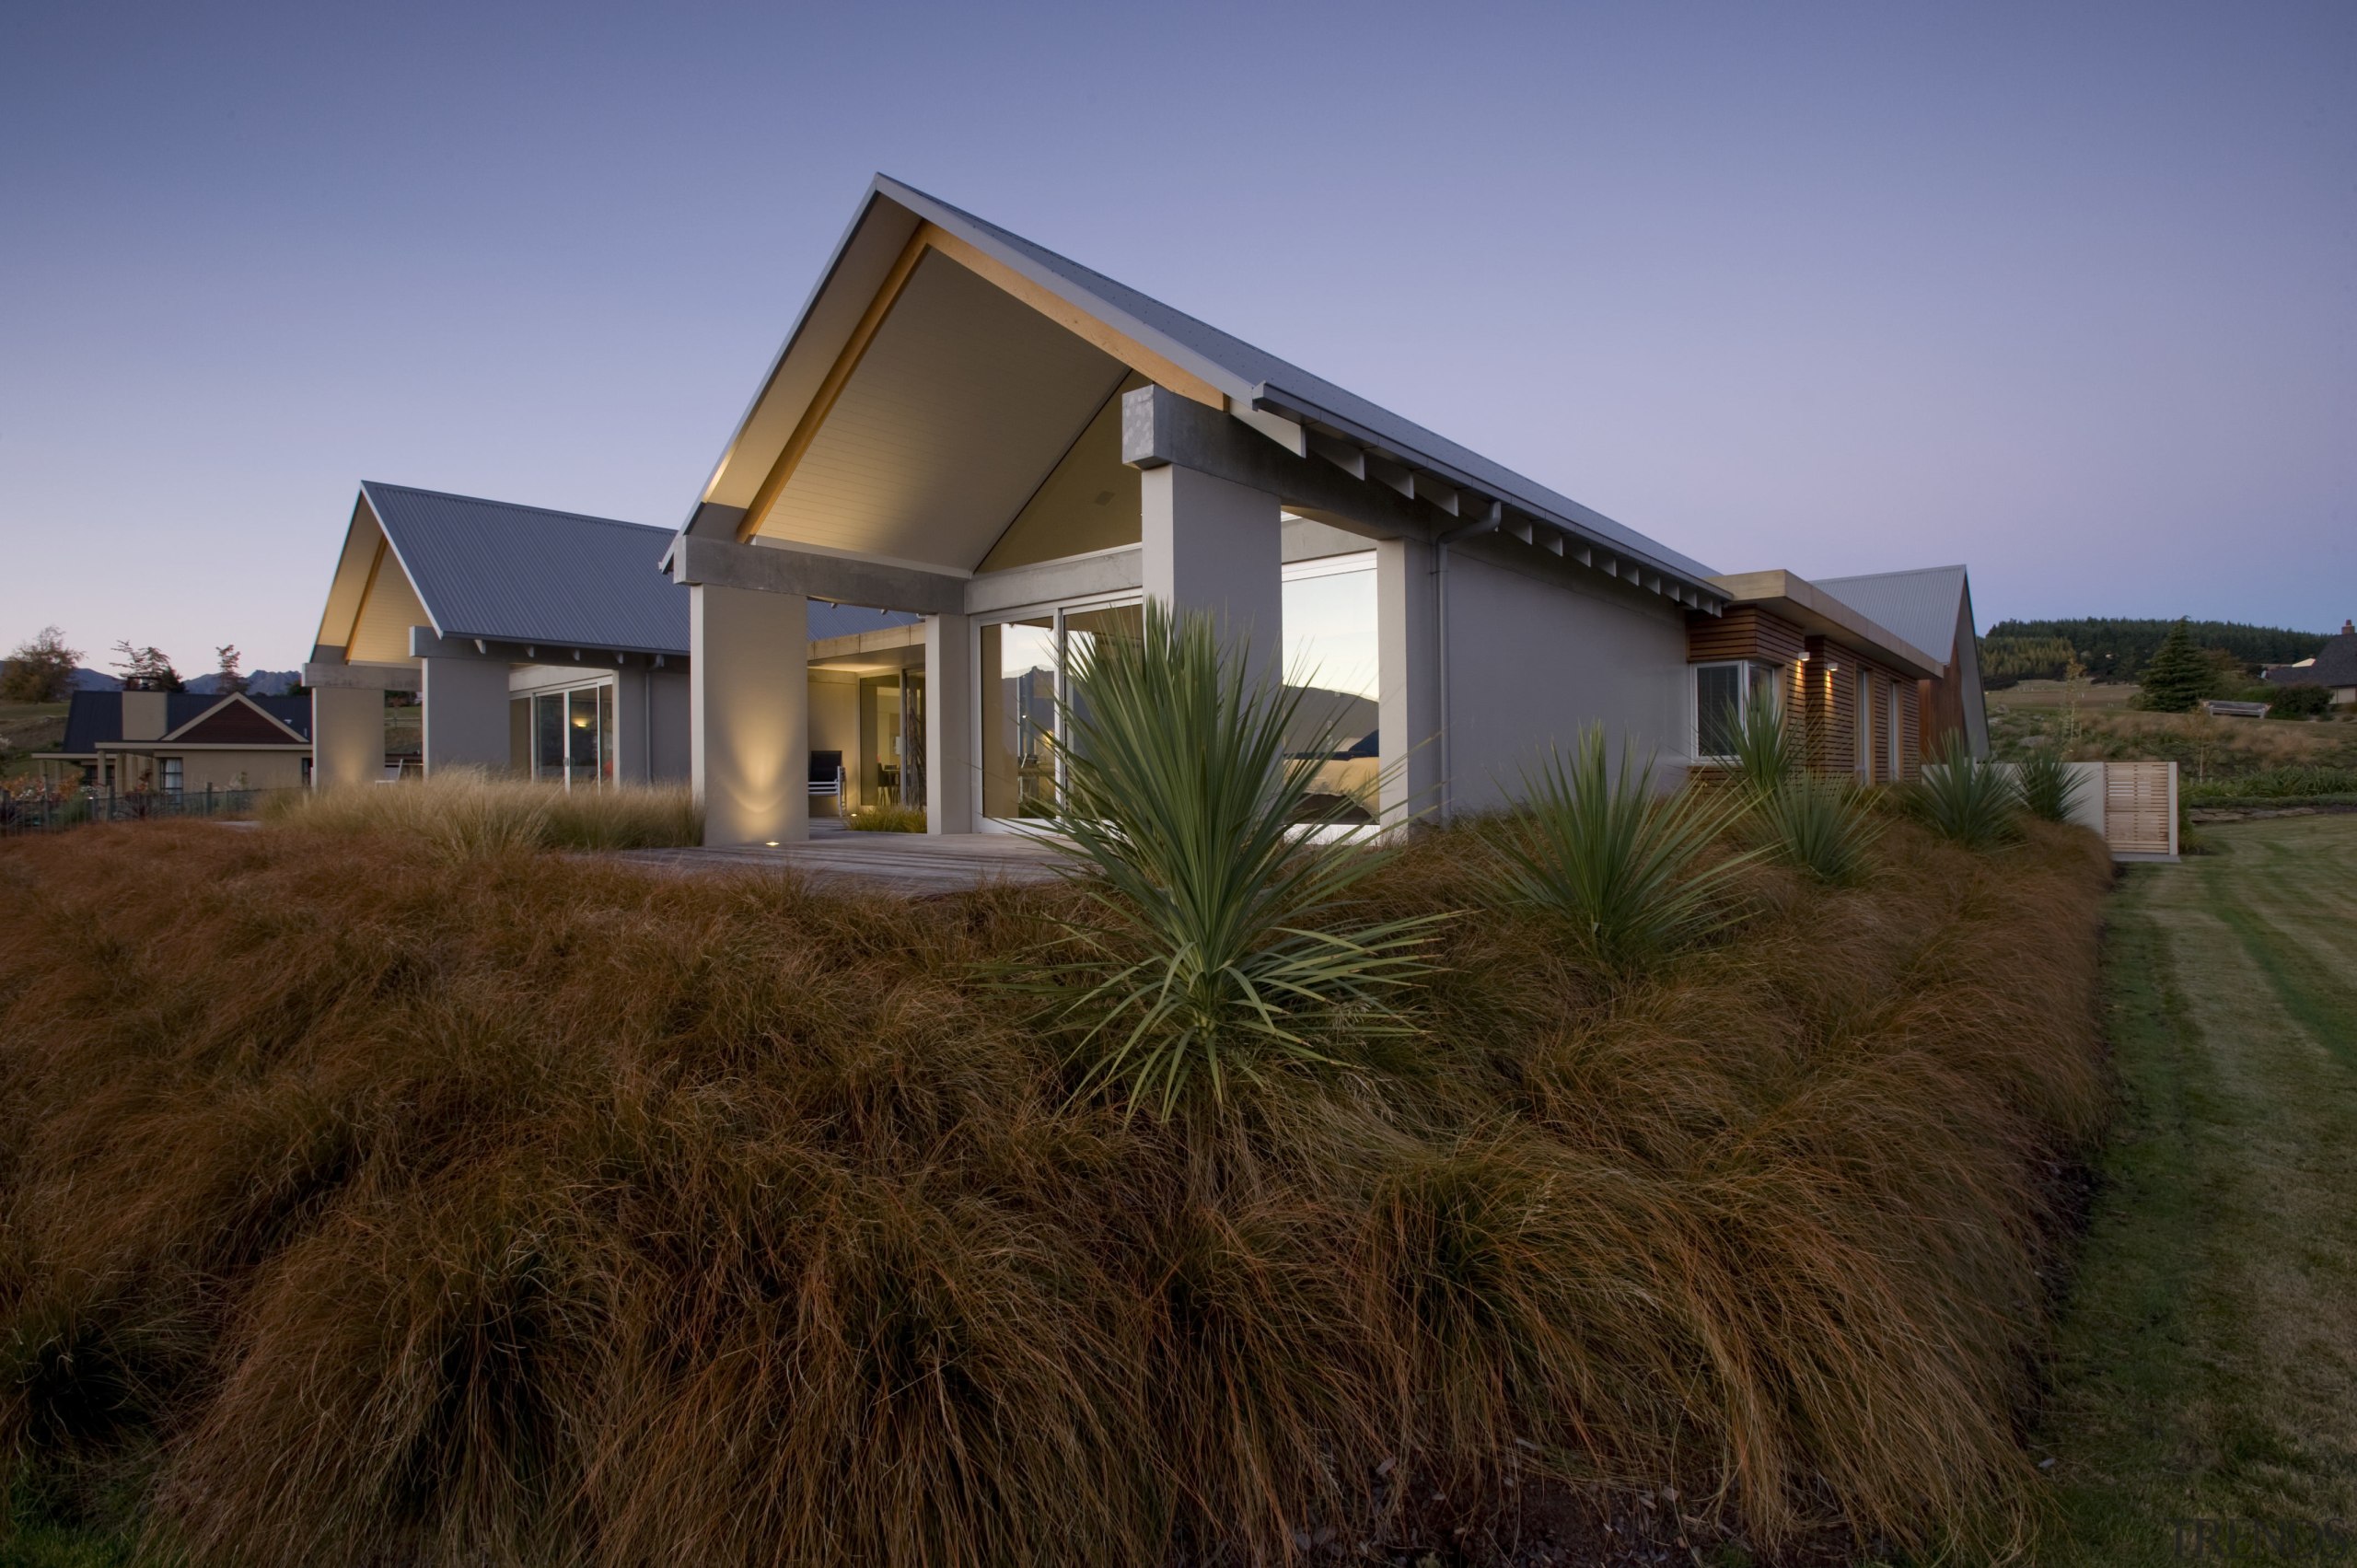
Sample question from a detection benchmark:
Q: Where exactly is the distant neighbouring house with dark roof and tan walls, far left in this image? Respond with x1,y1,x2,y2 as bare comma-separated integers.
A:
33,691,311,795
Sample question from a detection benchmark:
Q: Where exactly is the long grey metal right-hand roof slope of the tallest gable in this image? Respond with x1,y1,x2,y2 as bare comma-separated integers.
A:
872,175,1724,594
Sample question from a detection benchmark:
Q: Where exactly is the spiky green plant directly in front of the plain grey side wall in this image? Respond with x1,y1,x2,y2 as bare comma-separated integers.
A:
1502,724,1759,974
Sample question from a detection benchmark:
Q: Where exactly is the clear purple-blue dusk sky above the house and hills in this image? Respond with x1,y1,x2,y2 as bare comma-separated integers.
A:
0,0,2357,674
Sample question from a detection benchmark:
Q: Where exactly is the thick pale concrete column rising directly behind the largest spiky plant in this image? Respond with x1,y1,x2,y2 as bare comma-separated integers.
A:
1138,462,1284,681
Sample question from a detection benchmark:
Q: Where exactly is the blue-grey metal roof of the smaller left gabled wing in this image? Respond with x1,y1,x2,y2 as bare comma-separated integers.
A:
361,481,917,656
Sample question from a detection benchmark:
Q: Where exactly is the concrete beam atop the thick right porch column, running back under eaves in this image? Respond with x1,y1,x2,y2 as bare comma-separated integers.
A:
1122,387,1452,540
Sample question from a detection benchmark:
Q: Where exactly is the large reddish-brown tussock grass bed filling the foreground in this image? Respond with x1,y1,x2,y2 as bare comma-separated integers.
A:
0,806,2109,1568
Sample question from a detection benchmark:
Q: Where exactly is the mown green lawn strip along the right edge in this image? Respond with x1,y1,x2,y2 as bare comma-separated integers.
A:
2037,816,2357,1568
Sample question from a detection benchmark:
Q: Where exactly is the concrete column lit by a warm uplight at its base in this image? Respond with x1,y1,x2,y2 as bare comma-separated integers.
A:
689,583,811,844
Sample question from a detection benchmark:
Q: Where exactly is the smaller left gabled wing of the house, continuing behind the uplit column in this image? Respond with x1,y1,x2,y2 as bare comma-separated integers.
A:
304,483,914,787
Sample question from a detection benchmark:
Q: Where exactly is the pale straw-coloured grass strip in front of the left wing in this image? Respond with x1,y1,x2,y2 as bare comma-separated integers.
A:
264,769,704,861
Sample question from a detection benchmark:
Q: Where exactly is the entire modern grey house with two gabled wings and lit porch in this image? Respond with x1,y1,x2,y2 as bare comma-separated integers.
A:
304,177,1985,844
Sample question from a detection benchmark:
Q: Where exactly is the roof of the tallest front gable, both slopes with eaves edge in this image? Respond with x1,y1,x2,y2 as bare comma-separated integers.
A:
683,175,1716,606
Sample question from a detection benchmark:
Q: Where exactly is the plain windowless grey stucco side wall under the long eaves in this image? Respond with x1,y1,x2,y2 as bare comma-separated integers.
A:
1447,552,1690,811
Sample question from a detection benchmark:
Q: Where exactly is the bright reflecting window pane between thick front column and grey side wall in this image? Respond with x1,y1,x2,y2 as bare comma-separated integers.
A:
1283,552,1384,820
